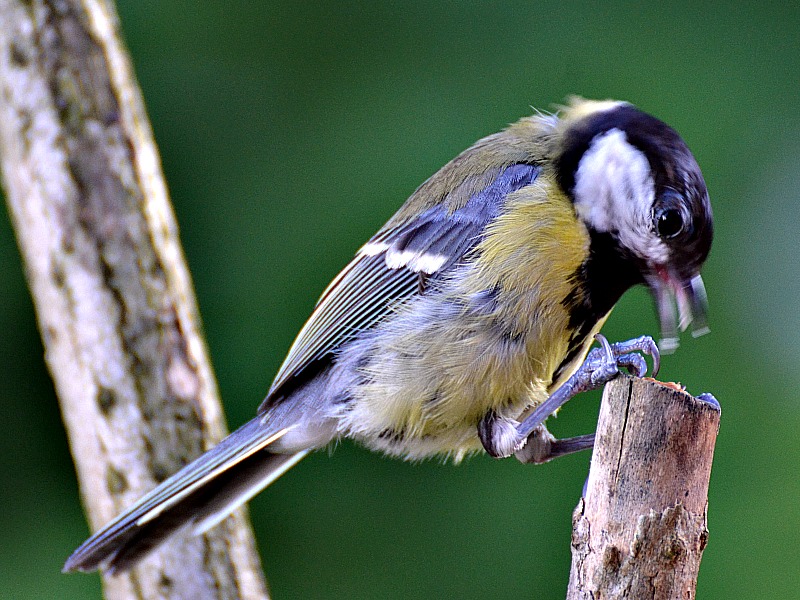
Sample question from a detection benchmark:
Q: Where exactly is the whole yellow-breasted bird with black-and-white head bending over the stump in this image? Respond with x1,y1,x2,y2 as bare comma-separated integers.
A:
64,97,713,573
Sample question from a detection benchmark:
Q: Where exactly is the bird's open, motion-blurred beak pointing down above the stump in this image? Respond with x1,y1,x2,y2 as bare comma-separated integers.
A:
646,265,709,354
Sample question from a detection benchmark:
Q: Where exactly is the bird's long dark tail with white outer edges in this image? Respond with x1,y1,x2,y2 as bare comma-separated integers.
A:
64,417,308,573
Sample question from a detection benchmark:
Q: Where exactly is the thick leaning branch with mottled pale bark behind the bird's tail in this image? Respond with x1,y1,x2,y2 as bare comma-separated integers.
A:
0,0,266,600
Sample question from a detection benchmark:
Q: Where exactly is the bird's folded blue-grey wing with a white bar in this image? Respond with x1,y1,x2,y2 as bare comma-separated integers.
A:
259,163,539,411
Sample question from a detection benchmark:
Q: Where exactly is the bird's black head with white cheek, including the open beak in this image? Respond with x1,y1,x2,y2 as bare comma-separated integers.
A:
555,99,713,352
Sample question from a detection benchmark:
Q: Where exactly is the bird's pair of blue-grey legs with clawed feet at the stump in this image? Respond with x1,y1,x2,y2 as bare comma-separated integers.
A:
478,334,660,462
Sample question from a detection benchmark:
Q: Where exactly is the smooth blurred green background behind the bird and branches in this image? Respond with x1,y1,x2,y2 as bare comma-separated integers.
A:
0,0,800,599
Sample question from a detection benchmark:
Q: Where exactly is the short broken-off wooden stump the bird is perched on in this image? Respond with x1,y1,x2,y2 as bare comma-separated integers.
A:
567,376,720,600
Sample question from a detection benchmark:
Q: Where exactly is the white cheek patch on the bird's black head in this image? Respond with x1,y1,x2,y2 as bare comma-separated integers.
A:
573,129,669,263
